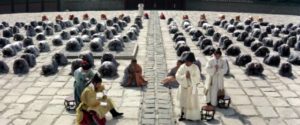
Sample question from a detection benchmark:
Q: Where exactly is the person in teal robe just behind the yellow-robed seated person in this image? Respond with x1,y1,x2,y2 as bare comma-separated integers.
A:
74,60,95,106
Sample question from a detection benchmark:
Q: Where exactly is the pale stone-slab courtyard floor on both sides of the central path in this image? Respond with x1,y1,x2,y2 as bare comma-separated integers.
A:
0,11,300,125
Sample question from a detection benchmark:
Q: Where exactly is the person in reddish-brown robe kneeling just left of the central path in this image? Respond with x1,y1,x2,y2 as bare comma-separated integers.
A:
121,59,147,86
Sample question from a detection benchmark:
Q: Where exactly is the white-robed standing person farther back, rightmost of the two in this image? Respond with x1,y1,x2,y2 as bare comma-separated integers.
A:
204,48,228,106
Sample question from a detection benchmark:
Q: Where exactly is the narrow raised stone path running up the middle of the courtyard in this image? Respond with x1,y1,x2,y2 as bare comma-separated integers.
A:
141,11,175,125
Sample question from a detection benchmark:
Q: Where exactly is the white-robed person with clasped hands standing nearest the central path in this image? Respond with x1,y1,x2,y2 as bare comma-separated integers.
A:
176,52,201,121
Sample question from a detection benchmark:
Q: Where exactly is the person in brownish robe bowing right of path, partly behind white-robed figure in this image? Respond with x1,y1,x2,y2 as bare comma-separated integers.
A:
161,60,184,85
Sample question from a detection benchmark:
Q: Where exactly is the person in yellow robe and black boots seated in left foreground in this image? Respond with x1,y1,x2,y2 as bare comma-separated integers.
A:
76,74,123,125
